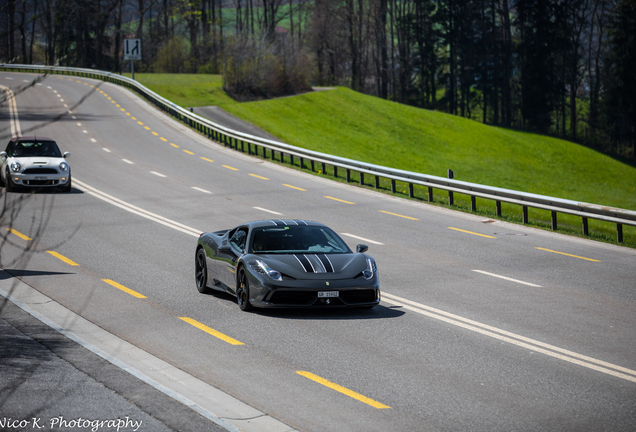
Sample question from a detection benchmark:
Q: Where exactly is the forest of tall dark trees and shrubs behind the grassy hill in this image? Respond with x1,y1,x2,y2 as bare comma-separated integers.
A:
0,0,636,160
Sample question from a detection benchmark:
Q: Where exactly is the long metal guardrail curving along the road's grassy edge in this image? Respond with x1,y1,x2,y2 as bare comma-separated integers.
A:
0,64,636,243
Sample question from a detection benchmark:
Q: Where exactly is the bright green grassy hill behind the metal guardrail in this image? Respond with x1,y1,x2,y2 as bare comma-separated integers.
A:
130,74,636,245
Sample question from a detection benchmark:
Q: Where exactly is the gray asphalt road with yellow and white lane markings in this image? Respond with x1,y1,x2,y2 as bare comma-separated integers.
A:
0,73,636,432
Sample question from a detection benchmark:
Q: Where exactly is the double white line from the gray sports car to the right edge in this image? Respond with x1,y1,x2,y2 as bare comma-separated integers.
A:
382,291,636,383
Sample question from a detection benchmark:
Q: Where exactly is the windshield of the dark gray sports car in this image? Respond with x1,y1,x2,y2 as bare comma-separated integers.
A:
251,225,351,253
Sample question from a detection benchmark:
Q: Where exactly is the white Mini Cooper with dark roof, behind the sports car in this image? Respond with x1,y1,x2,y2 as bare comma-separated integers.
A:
0,136,71,192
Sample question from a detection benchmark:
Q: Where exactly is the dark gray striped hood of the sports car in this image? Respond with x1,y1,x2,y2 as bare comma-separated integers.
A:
253,253,368,280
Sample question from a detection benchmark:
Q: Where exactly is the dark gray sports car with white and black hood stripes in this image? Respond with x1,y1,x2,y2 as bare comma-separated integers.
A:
195,220,380,311
